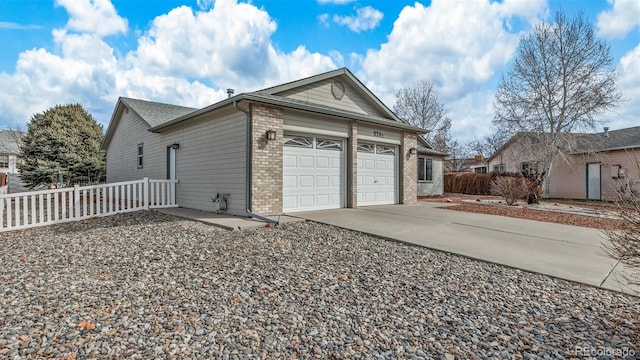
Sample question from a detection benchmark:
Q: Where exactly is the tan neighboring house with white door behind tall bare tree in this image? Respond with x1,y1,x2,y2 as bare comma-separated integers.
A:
487,126,640,200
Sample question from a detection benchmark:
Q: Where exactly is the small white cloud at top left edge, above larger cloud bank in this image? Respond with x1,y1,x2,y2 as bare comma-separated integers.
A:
56,0,127,37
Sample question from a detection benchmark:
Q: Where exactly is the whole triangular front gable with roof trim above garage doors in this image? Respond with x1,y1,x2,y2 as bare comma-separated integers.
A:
254,68,402,122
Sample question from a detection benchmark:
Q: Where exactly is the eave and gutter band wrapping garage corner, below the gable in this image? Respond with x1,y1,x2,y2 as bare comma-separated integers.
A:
149,93,428,133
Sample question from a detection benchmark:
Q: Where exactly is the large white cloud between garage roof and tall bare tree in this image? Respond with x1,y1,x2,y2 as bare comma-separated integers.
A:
360,0,546,143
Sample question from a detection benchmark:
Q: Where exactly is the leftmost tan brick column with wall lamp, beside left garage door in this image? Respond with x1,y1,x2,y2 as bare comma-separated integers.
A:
251,104,284,215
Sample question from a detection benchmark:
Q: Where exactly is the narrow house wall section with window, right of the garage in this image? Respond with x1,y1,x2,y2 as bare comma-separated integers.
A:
418,136,447,196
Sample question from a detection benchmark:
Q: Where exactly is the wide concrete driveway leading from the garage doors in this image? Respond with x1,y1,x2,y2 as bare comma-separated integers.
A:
290,202,640,293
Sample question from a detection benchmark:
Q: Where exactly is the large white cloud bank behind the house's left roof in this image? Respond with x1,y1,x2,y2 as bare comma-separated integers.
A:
0,0,341,128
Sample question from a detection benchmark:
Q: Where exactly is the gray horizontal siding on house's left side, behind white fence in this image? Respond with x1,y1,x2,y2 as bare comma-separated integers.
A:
107,105,246,215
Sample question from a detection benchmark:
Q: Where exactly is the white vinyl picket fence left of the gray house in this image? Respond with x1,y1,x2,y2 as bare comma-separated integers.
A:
0,178,178,232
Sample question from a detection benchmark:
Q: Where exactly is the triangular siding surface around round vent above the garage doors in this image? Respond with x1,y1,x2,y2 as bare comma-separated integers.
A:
277,79,387,117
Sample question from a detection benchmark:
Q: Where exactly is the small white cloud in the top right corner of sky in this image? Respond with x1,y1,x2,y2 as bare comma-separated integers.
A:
596,0,640,38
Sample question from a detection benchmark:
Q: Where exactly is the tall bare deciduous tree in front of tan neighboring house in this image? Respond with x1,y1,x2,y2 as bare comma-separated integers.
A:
494,12,621,195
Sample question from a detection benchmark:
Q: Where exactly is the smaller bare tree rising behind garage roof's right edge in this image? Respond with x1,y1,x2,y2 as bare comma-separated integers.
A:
393,81,451,151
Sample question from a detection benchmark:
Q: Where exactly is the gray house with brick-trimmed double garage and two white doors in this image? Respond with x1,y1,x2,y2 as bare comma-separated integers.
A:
102,68,424,216
